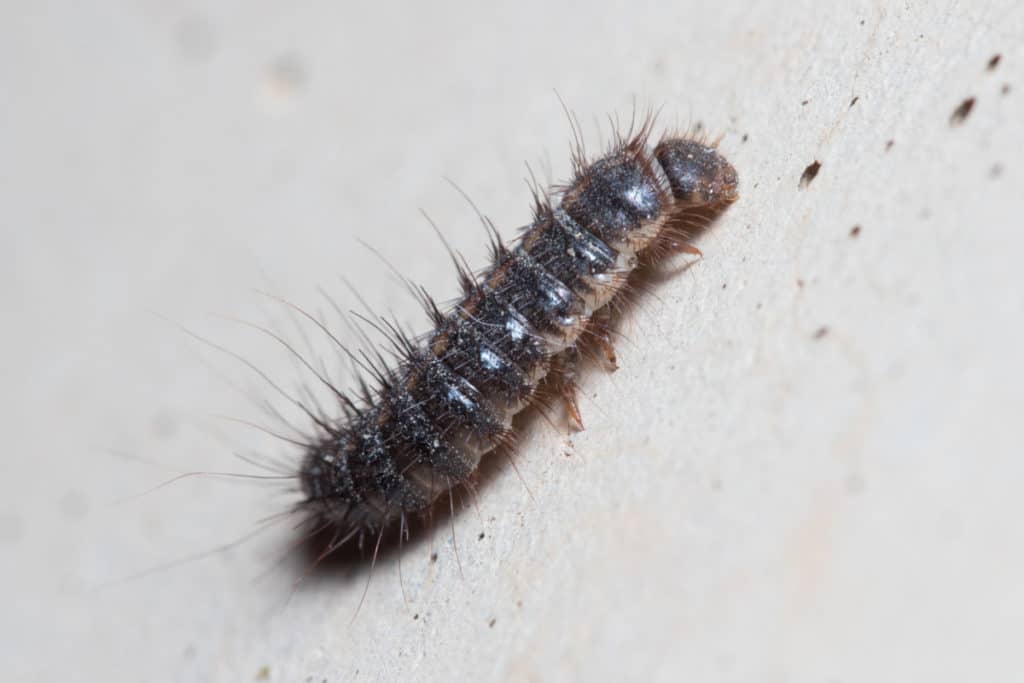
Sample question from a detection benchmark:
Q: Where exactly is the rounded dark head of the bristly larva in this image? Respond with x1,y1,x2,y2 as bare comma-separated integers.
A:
654,137,739,206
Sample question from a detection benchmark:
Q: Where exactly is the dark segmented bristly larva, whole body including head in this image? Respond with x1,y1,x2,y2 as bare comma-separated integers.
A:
300,121,737,543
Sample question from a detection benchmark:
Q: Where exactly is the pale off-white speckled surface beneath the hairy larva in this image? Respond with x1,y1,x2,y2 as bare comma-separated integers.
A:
0,0,1024,682
